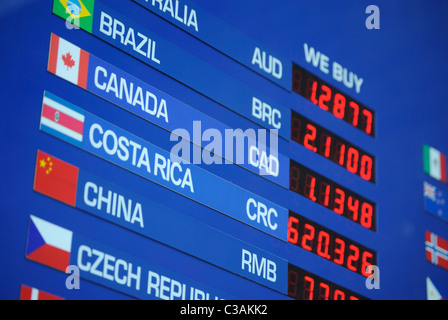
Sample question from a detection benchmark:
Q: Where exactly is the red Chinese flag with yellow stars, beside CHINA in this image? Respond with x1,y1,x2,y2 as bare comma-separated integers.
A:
33,150,79,207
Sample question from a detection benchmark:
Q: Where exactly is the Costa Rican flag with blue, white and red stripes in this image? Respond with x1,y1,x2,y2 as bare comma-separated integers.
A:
40,91,85,147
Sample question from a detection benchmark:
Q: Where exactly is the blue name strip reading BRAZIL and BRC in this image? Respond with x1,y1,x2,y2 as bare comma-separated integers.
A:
53,1,290,139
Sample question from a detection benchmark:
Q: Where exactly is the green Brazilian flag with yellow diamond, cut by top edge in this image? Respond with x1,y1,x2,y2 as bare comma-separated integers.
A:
53,0,95,33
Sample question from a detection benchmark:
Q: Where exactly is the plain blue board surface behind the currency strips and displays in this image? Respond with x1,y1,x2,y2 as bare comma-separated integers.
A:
0,0,448,299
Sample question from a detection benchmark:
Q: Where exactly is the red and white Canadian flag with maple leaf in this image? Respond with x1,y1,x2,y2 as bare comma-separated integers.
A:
47,33,89,89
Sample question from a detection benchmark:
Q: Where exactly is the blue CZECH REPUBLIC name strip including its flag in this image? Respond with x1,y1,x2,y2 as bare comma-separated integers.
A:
25,215,286,300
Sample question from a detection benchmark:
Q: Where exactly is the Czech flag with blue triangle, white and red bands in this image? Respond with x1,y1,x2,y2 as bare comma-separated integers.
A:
26,215,73,272
